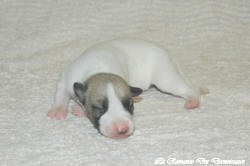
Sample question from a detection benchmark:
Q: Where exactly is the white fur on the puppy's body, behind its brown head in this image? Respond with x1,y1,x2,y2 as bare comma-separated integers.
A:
53,39,199,108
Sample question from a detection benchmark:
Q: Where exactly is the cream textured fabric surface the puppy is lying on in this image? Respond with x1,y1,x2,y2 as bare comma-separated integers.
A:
0,0,250,166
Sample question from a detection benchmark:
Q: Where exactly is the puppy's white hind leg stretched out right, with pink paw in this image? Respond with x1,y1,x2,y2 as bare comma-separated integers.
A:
152,60,200,109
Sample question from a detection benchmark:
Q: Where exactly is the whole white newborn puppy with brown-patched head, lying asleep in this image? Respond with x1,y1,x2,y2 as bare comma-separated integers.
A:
48,39,206,138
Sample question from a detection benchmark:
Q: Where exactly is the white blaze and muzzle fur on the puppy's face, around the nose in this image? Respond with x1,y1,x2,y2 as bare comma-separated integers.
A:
99,83,134,136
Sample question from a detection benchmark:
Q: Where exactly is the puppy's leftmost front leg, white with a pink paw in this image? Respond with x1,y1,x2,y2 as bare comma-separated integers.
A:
48,82,70,120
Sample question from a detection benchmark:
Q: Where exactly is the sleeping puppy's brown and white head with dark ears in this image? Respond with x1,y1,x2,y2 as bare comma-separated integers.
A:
74,73,142,138
